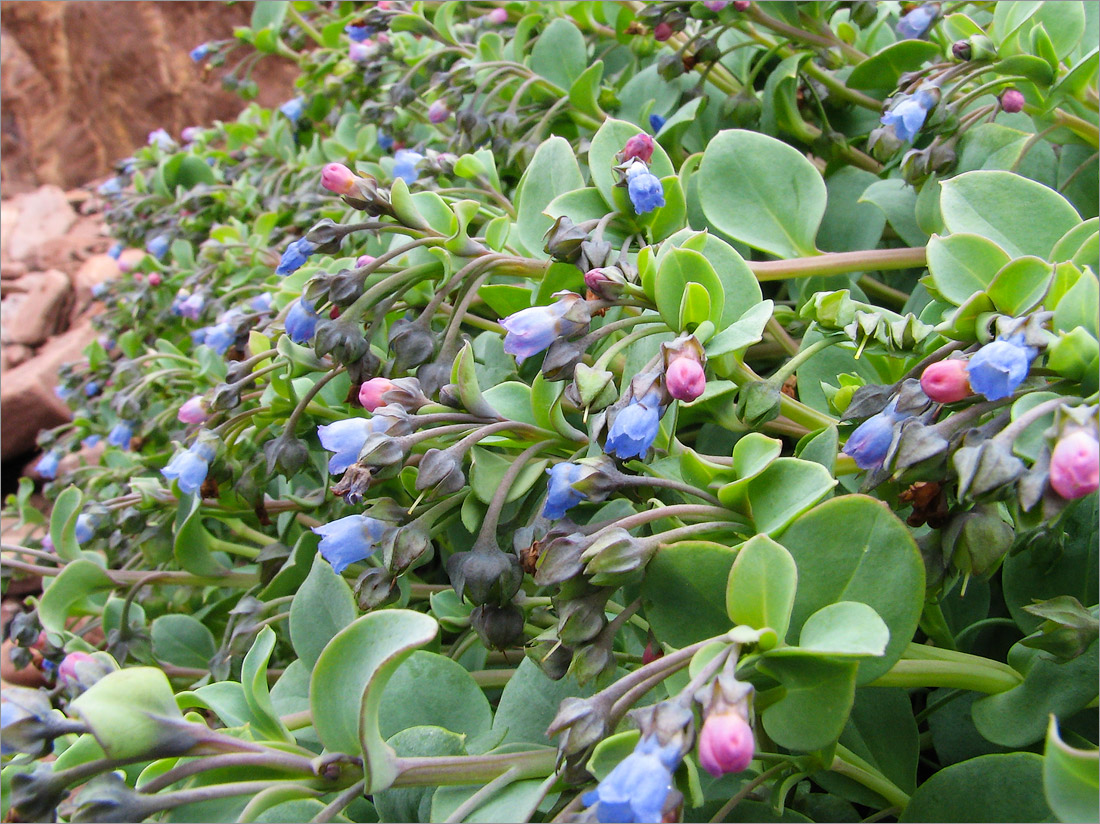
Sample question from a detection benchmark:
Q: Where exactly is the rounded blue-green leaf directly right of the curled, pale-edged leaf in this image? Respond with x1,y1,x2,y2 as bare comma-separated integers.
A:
378,650,493,739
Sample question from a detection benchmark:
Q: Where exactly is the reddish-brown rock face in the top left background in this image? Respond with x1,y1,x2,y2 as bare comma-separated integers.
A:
0,0,294,189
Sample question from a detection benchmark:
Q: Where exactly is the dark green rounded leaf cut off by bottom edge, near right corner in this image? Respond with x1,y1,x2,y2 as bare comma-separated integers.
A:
899,752,1051,822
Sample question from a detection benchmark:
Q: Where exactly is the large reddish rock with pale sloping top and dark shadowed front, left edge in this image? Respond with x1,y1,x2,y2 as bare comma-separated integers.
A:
0,319,97,461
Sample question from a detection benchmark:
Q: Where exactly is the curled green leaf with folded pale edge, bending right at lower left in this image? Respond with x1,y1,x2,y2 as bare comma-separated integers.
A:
309,609,439,792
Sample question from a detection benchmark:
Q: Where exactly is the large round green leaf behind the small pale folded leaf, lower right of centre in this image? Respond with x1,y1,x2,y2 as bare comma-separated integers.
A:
780,495,924,683
